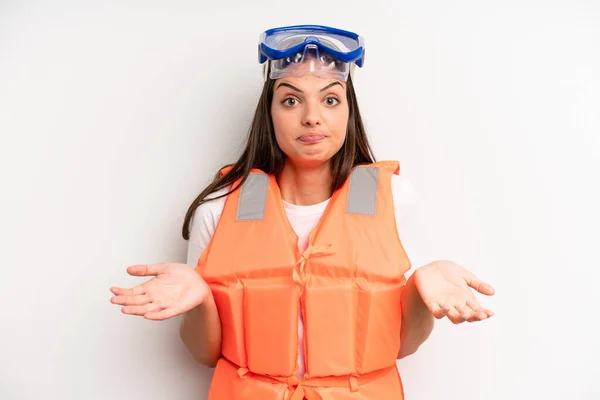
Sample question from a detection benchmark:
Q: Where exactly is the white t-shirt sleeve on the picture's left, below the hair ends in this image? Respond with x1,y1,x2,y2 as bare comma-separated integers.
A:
187,187,229,268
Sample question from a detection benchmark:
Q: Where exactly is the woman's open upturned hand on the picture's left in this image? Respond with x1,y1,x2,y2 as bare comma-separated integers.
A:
110,263,210,320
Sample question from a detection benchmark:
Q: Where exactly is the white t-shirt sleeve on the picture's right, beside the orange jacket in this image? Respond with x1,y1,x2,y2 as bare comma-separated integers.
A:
392,175,419,268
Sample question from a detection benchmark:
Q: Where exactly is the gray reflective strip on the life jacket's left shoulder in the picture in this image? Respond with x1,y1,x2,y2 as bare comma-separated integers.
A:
236,173,269,221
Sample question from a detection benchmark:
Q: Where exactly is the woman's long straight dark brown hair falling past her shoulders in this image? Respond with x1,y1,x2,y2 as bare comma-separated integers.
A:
182,76,375,240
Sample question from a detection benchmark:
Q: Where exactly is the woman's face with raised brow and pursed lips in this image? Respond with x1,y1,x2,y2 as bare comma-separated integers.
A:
271,73,349,168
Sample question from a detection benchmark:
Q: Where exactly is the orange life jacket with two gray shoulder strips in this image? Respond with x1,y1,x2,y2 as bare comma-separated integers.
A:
196,161,410,400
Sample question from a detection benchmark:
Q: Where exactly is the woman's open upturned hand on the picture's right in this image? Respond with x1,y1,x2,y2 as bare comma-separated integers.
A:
414,261,495,324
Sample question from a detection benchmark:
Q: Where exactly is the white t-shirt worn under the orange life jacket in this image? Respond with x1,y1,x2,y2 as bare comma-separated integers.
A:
187,175,417,378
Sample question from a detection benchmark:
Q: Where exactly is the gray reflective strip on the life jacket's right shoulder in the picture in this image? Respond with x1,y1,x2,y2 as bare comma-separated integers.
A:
346,167,379,216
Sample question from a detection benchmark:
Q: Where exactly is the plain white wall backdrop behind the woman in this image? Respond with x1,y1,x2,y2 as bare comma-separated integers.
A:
0,0,600,400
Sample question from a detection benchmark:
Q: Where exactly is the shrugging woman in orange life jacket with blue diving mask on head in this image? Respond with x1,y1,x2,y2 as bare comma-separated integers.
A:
111,26,494,400
